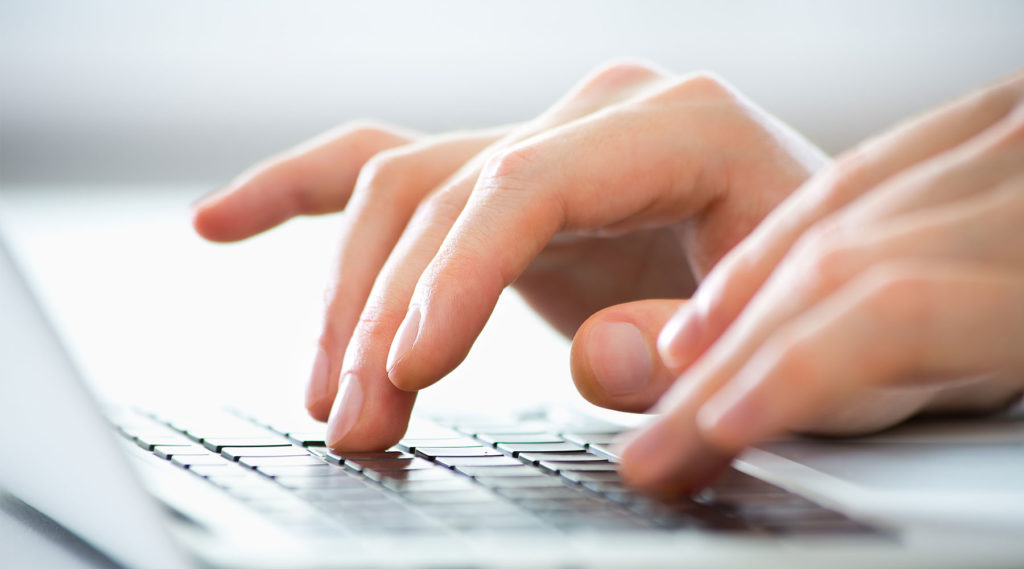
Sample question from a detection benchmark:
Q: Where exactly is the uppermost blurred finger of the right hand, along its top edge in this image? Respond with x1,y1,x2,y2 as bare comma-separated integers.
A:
658,71,1024,370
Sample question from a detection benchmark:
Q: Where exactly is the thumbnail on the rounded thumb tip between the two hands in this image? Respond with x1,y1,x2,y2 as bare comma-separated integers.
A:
587,322,653,395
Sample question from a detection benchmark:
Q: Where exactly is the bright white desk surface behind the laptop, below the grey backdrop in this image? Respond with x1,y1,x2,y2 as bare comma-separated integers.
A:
0,186,582,410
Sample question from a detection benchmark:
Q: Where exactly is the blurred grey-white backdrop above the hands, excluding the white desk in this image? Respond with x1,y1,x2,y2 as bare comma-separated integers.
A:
8,0,1024,184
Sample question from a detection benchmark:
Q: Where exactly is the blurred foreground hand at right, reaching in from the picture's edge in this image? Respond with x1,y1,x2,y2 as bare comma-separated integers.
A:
622,75,1024,493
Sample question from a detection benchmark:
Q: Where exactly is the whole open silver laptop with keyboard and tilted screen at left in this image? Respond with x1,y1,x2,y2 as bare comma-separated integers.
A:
0,222,1024,569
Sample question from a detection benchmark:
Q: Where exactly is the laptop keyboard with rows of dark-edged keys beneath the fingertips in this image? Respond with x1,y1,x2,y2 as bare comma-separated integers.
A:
109,409,877,535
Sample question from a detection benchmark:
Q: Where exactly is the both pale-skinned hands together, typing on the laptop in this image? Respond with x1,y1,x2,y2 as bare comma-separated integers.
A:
195,61,1024,494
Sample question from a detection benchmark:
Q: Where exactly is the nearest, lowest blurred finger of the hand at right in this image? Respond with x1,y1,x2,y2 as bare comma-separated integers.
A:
697,263,1024,452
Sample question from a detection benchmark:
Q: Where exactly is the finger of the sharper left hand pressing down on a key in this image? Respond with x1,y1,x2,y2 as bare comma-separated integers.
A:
328,63,663,450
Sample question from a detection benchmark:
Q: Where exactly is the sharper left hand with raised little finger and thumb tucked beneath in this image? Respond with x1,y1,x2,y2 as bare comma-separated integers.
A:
195,63,826,450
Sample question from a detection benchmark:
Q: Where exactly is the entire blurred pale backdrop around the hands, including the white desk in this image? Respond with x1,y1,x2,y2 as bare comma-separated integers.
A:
0,0,1024,413
